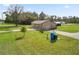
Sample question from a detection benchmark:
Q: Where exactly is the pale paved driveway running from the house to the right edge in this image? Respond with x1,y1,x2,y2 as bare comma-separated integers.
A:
50,30,79,40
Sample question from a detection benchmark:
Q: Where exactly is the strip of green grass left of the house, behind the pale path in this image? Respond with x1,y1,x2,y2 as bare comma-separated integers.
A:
0,24,31,31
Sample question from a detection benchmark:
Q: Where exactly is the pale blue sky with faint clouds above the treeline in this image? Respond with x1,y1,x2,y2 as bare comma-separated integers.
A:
0,4,79,18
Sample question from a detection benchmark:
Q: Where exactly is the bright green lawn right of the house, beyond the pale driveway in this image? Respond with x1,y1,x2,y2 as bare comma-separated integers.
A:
57,24,79,32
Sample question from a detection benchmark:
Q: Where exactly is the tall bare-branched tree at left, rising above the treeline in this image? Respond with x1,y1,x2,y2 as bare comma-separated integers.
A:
7,5,23,26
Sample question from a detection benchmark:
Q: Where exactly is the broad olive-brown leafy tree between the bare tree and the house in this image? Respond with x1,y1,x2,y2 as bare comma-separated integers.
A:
19,12,38,25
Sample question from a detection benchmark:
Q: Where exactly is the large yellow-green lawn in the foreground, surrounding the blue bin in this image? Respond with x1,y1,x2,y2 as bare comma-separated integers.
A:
0,31,79,55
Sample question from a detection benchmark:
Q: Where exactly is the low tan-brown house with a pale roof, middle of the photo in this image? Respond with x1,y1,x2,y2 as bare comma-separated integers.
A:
32,20,56,30
